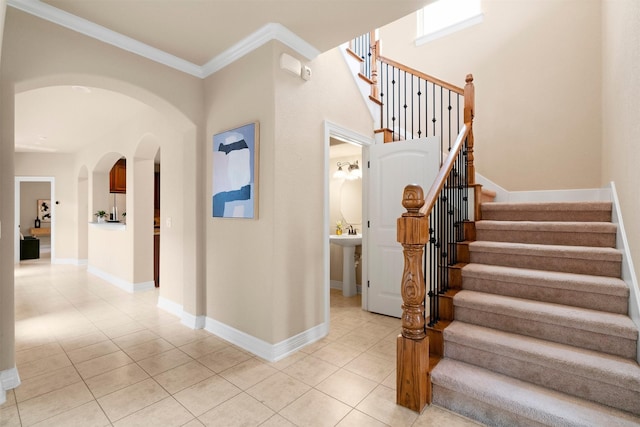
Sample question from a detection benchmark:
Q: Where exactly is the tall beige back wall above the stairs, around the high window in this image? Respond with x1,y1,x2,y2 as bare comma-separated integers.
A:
380,0,601,191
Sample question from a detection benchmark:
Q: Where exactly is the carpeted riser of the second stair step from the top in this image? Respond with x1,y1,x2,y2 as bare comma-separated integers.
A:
476,229,616,248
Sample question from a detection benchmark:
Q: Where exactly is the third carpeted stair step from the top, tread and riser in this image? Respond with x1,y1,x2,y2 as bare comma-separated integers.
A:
469,241,622,277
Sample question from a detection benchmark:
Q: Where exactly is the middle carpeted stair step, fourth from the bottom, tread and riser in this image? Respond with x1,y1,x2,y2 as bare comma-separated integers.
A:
462,263,629,314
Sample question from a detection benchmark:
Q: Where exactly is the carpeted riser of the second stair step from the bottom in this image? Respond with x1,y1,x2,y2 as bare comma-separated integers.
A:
445,342,640,415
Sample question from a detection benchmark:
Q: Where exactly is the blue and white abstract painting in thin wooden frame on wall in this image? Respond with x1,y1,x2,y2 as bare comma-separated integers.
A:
211,122,260,219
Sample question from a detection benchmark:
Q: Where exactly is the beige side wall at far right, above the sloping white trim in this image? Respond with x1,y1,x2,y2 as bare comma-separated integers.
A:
602,0,640,282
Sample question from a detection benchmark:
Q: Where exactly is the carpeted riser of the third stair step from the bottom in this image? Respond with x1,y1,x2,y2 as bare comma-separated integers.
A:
455,306,636,359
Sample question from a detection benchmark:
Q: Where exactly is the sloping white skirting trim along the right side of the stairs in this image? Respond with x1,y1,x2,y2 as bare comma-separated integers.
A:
609,181,640,363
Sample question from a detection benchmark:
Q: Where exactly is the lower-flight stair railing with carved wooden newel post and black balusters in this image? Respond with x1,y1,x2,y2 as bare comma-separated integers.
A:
396,74,478,412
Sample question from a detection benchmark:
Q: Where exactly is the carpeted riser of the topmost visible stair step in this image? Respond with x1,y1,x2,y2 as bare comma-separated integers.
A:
482,209,611,222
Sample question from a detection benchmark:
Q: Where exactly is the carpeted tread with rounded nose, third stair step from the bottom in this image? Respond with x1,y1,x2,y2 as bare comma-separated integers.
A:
453,290,638,340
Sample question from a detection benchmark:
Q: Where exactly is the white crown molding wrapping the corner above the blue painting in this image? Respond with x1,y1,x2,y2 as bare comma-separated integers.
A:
202,23,320,77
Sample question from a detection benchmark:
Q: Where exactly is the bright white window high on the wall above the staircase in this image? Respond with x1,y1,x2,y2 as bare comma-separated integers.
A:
416,0,482,46
